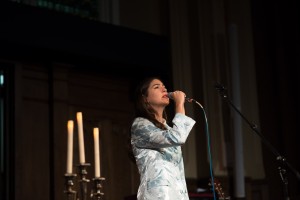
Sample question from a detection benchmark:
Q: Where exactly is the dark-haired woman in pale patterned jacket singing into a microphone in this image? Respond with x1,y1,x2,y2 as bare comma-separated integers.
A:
131,78,195,200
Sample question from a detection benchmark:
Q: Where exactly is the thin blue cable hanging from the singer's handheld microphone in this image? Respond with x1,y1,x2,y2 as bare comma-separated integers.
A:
186,98,217,200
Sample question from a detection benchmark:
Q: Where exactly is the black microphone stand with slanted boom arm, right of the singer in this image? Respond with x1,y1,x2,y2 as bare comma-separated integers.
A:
215,83,300,200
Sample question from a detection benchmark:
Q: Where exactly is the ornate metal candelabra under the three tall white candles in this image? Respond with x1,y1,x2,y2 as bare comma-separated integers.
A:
64,163,105,200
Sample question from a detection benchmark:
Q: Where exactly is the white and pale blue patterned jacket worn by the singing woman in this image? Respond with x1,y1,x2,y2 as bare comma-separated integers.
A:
131,113,195,200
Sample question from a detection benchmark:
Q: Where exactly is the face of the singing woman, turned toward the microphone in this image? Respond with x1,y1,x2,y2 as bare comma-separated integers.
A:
146,79,170,108
